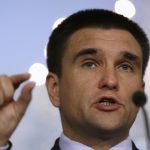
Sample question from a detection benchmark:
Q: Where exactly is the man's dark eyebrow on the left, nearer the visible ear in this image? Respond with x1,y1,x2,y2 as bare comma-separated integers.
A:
73,48,97,62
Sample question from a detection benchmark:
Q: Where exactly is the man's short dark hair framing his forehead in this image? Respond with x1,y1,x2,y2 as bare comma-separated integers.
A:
47,9,150,77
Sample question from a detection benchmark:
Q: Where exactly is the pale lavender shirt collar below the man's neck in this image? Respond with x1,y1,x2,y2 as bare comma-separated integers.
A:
59,133,132,150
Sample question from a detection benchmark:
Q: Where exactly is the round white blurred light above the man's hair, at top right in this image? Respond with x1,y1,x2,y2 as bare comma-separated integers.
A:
115,0,136,19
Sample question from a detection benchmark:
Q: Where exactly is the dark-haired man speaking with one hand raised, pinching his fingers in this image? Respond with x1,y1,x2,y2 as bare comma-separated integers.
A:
0,9,150,150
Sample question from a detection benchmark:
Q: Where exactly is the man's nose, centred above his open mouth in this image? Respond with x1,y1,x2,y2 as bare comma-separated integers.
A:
99,68,119,91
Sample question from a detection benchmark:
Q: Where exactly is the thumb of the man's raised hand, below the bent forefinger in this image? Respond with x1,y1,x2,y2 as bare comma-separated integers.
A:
14,82,35,121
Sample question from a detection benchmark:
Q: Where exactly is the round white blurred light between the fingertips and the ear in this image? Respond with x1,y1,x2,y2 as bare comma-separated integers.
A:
28,63,48,86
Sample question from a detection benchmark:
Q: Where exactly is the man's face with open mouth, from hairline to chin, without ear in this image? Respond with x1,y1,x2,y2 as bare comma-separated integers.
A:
47,28,143,140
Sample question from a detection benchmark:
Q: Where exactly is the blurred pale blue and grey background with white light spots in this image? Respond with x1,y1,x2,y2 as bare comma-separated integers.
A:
0,0,150,150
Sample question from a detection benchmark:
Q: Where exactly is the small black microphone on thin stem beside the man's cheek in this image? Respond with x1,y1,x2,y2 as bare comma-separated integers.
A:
132,91,150,150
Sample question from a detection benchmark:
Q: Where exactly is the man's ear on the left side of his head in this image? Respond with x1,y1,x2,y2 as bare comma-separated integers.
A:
46,72,60,107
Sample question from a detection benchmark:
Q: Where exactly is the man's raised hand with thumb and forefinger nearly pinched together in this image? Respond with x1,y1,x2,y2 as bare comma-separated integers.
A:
0,74,35,146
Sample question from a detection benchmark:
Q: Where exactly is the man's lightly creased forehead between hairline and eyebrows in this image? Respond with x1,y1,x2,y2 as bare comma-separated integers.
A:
65,28,142,55
